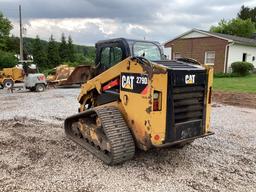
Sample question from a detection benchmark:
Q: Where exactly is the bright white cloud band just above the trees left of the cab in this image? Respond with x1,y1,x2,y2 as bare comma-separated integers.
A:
12,18,123,43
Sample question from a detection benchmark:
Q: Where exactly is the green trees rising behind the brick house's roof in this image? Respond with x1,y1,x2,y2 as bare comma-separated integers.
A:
210,5,256,38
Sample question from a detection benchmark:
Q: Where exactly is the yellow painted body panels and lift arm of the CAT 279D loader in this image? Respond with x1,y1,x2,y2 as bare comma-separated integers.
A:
78,58,213,150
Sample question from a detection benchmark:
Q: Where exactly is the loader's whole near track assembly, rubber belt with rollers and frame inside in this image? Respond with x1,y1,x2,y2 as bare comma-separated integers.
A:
64,106,135,165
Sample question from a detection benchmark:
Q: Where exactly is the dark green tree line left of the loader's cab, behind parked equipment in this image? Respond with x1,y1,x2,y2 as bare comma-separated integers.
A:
0,12,95,70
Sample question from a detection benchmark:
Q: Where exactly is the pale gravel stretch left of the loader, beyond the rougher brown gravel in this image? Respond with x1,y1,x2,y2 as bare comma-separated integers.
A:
0,88,80,124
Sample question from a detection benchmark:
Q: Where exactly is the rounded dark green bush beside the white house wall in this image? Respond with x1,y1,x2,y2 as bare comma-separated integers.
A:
231,61,254,76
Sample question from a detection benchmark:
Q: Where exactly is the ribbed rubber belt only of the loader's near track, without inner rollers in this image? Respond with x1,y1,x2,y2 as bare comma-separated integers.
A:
64,107,135,165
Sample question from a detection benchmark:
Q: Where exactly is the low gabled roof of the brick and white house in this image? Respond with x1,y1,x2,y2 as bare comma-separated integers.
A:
164,29,256,46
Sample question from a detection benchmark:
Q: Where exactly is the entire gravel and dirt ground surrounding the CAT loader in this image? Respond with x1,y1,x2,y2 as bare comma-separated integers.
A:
0,89,256,192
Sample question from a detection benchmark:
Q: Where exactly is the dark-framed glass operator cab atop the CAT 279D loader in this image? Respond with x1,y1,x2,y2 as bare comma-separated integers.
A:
95,38,164,74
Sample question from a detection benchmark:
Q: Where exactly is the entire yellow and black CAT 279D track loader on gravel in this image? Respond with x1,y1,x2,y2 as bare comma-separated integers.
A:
64,38,213,165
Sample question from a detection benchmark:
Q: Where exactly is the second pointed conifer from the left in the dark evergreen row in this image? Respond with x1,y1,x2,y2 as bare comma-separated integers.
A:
47,35,60,67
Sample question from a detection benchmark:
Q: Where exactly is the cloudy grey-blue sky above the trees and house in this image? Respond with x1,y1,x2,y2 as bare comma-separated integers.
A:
0,0,256,45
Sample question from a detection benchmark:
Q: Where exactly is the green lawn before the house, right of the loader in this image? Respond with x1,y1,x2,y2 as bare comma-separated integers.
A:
213,74,256,93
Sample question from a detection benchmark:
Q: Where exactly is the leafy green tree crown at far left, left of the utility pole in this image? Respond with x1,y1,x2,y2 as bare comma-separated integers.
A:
0,12,12,50
